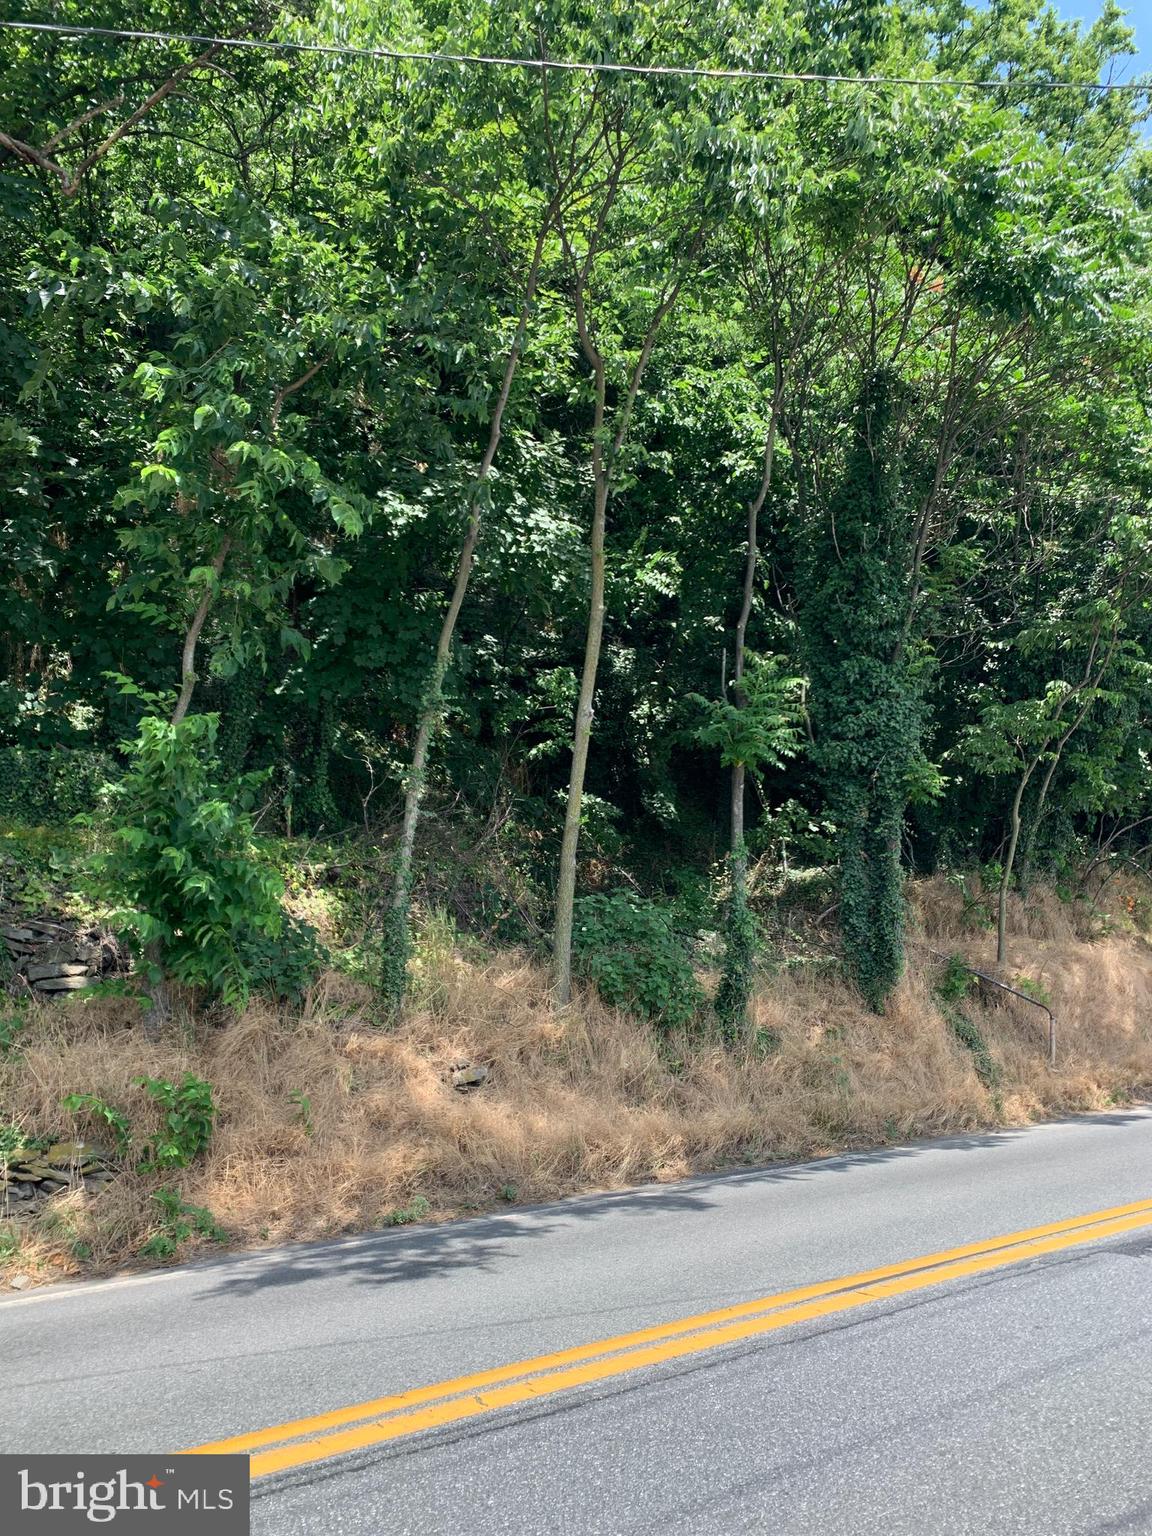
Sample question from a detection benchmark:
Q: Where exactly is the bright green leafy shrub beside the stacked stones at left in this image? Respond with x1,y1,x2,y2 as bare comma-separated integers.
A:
94,714,284,1006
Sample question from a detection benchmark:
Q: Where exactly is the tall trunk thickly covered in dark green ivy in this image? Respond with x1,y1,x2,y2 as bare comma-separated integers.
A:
800,372,920,1012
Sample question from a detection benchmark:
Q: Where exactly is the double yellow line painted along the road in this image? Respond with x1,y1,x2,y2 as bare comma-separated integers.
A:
186,1200,1152,1478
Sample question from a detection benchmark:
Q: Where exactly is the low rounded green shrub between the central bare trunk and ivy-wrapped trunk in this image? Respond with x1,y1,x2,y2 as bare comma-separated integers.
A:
573,891,703,1029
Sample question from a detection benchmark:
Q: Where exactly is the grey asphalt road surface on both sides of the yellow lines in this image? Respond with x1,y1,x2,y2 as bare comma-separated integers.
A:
0,1109,1152,1536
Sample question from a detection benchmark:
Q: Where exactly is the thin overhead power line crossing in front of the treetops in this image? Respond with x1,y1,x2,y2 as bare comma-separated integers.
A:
0,22,1152,95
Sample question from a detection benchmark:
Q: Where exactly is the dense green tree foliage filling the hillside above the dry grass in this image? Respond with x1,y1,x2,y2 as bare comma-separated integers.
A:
0,0,1152,1031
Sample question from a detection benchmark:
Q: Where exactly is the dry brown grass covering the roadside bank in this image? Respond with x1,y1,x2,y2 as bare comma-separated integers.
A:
0,882,1152,1279
